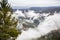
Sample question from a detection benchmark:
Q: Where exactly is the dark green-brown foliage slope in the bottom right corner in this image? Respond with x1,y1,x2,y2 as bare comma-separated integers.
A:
37,29,60,40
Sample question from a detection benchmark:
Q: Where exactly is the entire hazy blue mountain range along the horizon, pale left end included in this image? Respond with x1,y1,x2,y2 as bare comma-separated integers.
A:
12,6,60,13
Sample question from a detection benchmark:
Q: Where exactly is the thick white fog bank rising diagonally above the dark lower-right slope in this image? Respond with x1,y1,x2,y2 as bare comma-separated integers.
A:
13,12,60,40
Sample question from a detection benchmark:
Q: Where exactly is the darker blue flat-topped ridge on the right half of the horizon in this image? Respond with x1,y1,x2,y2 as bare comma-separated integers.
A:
29,6,60,13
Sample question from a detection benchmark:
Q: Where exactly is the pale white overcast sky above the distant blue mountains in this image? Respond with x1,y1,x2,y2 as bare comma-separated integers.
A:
9,0,60,6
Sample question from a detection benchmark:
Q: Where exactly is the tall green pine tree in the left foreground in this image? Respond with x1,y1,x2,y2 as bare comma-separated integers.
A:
0,0,19,40
